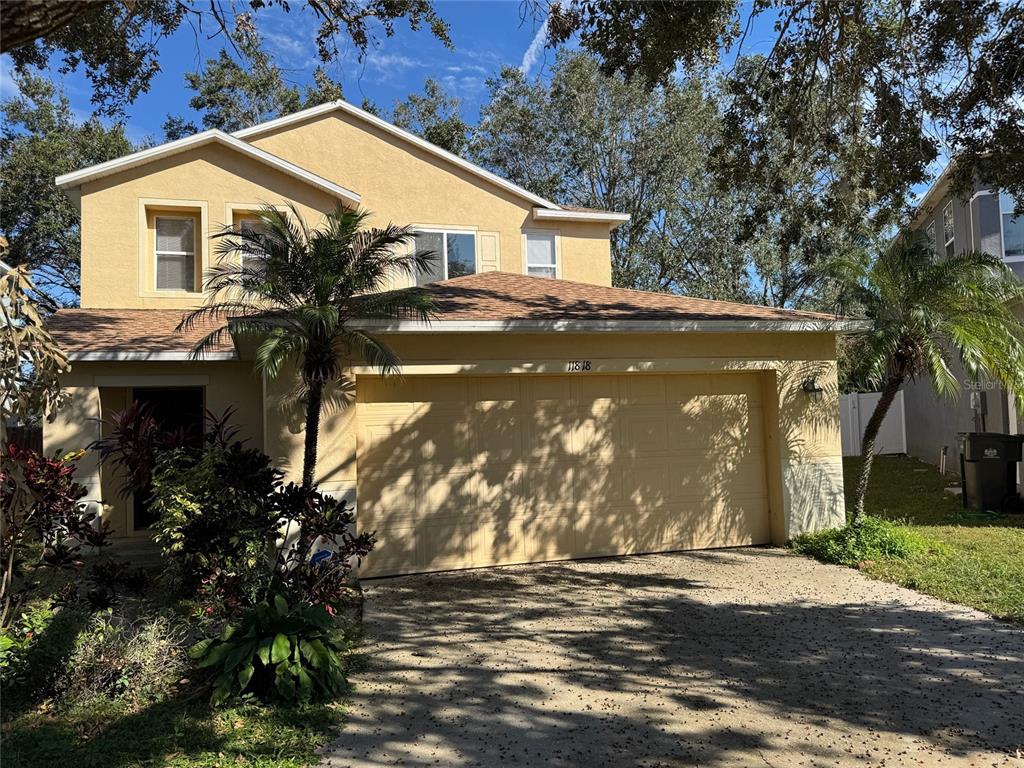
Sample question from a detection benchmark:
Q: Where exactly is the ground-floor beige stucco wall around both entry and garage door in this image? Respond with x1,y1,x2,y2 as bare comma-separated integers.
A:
44,333,845,543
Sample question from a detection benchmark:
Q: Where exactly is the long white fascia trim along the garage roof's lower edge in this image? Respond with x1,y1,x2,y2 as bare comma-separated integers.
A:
352,319,871,333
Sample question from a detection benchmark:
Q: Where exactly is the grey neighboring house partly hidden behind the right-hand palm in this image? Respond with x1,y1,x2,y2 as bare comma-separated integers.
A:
903,167,1024,487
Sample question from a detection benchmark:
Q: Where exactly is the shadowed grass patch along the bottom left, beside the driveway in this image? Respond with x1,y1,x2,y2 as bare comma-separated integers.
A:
3,697,342,768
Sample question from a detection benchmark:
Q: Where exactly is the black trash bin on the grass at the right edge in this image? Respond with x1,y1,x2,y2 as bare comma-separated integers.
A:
956,432,1024,512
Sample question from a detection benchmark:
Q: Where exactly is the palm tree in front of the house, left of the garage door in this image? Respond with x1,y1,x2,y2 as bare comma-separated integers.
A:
178,205,435,488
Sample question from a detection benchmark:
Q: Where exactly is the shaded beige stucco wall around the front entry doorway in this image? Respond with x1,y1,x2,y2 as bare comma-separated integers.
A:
43,361,263,536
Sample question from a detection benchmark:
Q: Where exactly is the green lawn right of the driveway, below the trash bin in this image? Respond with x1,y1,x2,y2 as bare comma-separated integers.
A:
844,456,1024,624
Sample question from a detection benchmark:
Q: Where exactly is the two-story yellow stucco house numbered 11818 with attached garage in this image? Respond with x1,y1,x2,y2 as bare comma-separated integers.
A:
46,102,857,575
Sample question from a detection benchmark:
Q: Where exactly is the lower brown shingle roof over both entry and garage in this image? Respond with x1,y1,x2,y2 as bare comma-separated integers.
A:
49,272,840,357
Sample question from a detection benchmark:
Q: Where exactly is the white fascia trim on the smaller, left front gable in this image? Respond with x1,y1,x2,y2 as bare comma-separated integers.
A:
54,128,362,205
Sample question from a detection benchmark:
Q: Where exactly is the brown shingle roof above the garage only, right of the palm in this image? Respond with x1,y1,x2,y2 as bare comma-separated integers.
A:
403,272,840,322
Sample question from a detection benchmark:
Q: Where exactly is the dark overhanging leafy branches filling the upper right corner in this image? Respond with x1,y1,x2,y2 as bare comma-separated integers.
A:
544,0,1024,218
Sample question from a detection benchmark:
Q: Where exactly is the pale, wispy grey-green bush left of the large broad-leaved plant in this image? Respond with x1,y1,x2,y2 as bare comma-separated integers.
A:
55,608,187,707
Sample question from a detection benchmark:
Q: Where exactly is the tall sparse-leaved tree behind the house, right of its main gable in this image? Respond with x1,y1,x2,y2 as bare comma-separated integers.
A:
471,51,748,299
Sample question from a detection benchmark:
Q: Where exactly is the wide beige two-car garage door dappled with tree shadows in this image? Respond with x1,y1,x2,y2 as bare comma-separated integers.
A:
357,373,770,575
